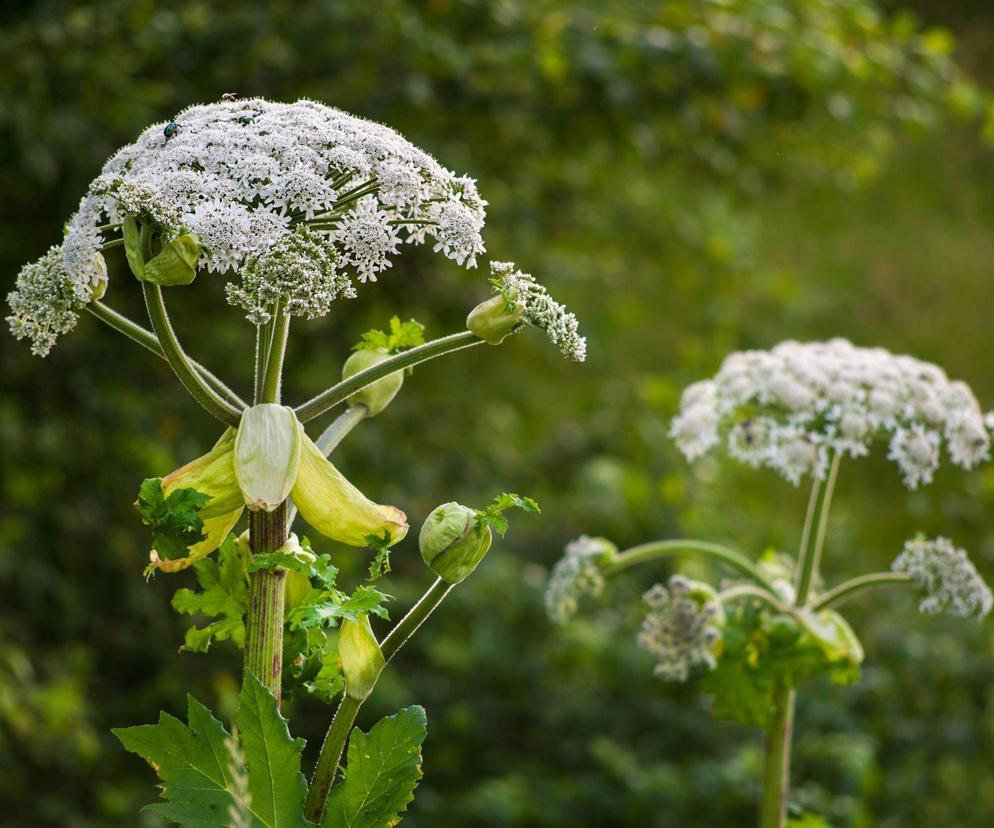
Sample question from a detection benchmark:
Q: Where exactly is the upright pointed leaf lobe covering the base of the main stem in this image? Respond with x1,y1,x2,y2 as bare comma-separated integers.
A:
235,673,308,828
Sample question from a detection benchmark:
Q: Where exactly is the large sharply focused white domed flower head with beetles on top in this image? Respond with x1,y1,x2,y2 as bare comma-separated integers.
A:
6,98,487,350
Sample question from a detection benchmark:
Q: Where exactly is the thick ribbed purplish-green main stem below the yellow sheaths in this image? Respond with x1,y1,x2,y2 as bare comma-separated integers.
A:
245,502,287,701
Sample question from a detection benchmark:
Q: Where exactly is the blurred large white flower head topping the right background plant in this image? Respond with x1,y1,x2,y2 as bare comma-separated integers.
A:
670,339,990,489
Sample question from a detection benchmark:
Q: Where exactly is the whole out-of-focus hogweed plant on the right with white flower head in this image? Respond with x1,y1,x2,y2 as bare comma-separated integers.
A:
546,339,994,828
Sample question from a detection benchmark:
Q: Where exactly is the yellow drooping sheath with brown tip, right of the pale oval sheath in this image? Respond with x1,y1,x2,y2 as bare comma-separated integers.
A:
291,428,407,546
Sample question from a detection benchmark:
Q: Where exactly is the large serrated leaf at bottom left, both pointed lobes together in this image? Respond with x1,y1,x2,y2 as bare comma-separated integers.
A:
113,675,311,828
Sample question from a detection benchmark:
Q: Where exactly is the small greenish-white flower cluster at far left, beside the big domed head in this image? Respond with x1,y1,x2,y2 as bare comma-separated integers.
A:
7,246,107,356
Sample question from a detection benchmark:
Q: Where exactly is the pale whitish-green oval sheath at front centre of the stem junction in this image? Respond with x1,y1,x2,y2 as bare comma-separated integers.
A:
234,403,301,512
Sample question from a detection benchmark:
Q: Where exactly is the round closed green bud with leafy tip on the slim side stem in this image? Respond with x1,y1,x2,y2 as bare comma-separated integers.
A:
418,503,493,584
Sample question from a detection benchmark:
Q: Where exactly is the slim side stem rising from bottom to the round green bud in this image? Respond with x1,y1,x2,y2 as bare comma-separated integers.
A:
304,578,452,822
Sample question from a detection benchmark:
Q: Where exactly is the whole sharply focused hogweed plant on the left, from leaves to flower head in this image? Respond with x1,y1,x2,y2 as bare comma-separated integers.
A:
8,96,585,828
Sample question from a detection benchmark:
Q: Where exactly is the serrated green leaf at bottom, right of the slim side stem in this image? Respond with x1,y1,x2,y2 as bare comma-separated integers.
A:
321,706,428,828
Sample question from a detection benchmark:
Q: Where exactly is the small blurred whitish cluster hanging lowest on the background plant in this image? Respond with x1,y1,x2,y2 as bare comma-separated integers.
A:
638,575,724,681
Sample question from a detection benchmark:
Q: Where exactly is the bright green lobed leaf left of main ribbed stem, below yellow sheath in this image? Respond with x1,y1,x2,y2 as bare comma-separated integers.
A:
172,535,249,653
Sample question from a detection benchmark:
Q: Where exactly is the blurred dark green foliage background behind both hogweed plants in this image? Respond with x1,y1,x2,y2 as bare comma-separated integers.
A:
0,0,994,828
